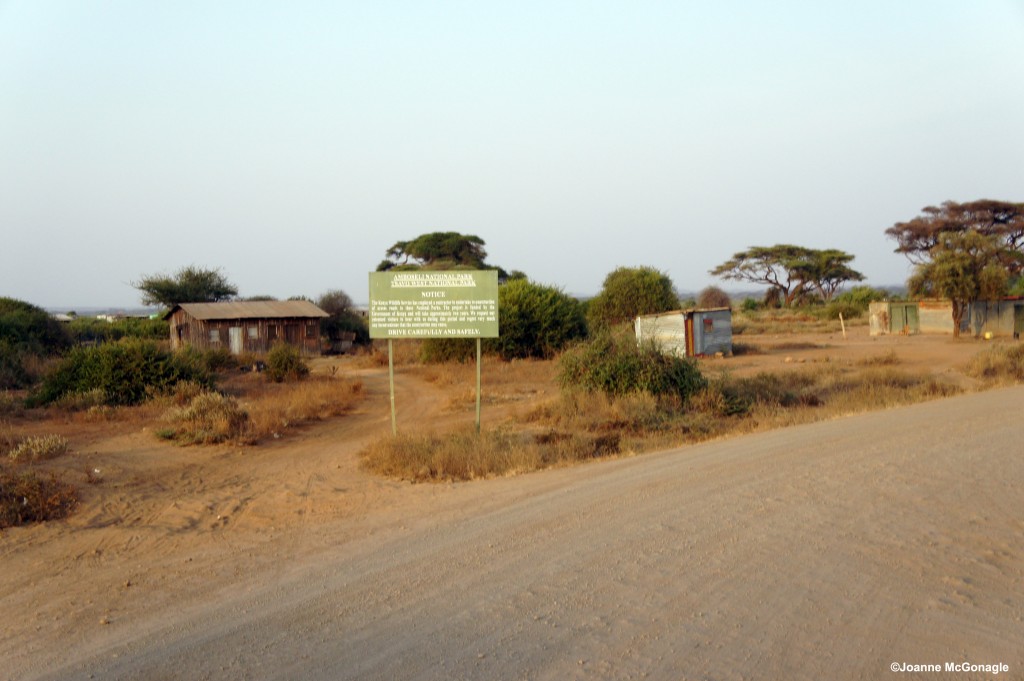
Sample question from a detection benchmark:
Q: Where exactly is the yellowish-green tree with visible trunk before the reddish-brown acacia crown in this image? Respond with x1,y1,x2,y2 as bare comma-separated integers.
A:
907,229,1024,337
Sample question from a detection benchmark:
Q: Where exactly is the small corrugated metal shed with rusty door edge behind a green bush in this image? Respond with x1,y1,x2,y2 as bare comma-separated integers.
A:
634,307,732,357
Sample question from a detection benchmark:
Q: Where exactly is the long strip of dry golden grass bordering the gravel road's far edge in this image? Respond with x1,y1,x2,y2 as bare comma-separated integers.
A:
362,354,959,480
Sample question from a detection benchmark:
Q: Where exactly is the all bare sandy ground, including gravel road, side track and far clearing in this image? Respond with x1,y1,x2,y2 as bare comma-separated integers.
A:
0,330,1024,679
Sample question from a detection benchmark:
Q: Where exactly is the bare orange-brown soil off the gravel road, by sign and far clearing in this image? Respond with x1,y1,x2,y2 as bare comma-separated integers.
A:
0,328,1011,671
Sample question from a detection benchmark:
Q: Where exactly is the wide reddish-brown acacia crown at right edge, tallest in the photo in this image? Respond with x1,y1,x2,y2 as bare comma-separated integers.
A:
886,199,1024,266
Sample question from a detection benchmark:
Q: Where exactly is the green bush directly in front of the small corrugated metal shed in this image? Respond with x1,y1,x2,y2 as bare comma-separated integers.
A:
559,333,708,400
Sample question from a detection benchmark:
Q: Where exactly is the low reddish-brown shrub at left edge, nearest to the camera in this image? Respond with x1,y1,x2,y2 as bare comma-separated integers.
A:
0,470,78,529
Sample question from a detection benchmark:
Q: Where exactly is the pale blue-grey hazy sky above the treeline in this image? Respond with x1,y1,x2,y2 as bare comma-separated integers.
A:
0,0,1024,309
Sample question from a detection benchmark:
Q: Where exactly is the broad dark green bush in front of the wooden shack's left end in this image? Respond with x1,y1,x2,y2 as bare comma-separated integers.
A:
31,339,211,406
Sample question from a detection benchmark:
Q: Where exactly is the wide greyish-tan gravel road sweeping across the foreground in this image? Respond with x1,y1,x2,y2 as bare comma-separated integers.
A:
12,387,1024,680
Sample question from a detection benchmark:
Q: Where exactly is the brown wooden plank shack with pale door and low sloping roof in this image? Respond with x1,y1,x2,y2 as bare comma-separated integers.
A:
163,300,330,356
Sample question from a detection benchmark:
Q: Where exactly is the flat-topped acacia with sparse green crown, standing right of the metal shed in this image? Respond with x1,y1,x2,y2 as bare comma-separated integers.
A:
711,244,864,306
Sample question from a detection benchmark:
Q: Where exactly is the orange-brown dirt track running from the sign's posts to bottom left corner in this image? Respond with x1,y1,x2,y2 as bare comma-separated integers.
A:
0,364,464,678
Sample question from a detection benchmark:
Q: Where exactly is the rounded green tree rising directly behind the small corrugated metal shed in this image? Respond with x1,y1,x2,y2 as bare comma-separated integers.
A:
587,267,679,327
